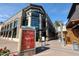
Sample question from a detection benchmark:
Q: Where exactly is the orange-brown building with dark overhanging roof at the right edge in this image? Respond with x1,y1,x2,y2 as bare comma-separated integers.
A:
66,3,79,44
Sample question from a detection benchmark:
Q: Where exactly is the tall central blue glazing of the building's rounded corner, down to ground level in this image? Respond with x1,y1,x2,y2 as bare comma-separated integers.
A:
31,11,39,40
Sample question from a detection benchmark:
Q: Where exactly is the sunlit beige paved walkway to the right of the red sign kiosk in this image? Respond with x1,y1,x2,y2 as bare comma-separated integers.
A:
34,40,79,56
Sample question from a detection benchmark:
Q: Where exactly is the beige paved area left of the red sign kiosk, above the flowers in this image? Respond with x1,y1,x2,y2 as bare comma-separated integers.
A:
0,39,18,51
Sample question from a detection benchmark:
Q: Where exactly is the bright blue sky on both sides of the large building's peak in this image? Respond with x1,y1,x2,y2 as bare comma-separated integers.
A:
0,3,72,23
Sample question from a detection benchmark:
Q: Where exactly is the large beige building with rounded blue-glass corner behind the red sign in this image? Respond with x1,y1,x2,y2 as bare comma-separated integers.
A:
0,4,55,54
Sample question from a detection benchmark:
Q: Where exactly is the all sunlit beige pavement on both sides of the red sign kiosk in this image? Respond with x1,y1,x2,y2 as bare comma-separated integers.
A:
0,39,79,56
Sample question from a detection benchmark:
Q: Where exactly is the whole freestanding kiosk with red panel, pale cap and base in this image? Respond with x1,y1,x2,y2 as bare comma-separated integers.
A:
21,27,36,55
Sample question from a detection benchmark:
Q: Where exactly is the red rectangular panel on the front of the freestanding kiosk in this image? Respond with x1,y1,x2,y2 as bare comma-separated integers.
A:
21,29,35,51
